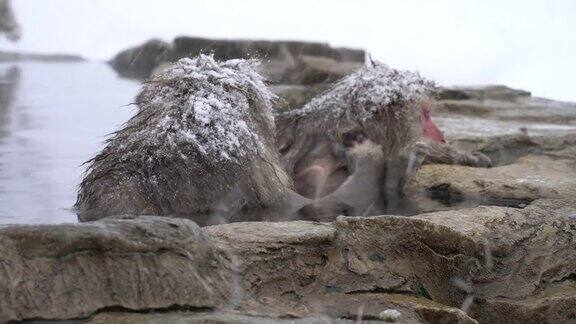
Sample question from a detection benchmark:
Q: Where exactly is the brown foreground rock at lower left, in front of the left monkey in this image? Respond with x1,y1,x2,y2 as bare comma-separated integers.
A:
0,217,234,322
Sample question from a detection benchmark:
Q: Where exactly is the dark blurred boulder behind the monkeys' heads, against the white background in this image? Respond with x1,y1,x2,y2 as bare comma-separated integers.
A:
109,37,365,83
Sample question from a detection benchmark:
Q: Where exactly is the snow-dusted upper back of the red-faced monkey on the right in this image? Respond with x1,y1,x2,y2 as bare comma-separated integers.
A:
277,62,436,166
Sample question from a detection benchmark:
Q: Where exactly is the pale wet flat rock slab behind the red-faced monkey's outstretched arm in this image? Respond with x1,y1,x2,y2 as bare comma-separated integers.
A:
434,86,576,159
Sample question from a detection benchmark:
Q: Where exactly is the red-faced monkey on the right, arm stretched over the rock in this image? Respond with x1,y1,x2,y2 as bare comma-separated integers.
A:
276,62,489,217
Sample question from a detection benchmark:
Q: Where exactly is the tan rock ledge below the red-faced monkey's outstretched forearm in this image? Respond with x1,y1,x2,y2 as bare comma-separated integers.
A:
409,151,576,211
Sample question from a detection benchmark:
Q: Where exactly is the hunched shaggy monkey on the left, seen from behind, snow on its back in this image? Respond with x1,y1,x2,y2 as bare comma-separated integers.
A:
75,55,306,221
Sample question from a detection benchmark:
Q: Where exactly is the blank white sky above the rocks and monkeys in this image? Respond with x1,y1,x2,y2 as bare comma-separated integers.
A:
0,0,576,101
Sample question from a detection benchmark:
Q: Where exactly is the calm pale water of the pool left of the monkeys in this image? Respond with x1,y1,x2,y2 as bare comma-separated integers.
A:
0,62,138,224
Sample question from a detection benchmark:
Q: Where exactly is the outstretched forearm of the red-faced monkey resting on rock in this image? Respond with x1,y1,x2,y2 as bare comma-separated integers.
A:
415,141,492,168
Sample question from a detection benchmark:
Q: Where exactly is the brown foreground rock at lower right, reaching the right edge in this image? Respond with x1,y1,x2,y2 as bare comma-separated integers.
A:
337,199,576,323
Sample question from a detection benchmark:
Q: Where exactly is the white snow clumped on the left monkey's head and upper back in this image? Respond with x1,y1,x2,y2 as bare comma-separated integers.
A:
133,55,275,160
